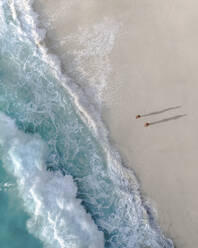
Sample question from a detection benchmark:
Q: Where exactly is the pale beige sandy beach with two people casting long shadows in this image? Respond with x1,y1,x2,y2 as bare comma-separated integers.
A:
34,0,198,248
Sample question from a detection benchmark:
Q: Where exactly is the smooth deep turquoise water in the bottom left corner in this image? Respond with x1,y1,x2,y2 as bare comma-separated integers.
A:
0,159,43,248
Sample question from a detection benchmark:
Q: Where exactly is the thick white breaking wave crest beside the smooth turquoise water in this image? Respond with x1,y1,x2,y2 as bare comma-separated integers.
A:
0,113,104,248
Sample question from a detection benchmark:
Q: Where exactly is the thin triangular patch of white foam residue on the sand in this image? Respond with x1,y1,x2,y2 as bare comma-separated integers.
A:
57,18,121,109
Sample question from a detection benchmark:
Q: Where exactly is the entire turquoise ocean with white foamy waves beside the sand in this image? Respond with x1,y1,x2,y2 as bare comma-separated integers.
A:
0,0,173,248
